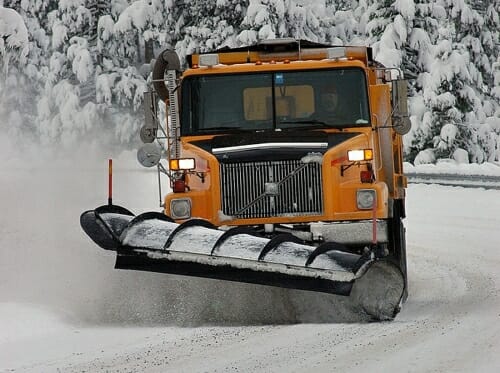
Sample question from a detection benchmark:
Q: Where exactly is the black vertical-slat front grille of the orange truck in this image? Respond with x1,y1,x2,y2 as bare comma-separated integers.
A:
220,160,323,219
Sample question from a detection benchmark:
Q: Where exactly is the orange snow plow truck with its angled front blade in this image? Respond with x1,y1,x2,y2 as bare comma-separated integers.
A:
80,39,410,320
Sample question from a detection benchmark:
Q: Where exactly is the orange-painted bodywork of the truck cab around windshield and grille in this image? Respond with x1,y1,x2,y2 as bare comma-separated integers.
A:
164,47,406,226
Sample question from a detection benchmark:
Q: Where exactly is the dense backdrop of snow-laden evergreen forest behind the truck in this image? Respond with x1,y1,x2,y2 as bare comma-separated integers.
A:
0,0,500,162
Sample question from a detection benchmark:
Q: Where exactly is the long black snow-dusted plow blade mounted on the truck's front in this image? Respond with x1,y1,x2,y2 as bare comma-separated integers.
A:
80,205,404,320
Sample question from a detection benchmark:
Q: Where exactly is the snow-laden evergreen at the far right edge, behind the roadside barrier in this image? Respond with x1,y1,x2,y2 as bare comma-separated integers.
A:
409,1,498,162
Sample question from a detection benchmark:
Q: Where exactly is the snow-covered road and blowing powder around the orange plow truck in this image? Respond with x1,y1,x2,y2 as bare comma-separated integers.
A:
0,146,500,372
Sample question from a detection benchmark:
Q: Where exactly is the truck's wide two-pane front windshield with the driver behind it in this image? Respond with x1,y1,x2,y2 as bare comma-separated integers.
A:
181,68,370,135
